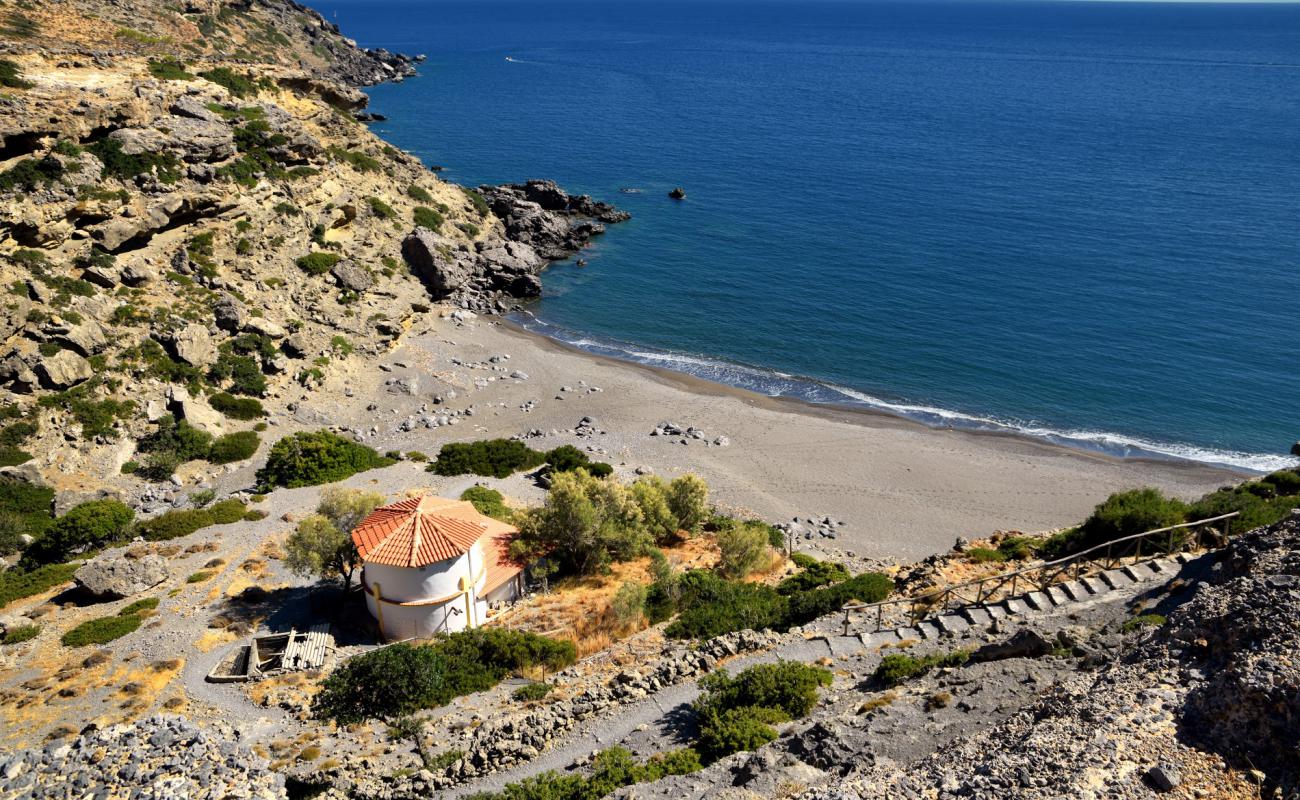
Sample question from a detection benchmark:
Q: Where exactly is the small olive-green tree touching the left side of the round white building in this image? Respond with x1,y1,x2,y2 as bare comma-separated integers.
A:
285,489,384,592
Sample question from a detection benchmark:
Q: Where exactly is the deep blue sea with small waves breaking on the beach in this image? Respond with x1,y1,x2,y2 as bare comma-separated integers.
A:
315,0,1300,470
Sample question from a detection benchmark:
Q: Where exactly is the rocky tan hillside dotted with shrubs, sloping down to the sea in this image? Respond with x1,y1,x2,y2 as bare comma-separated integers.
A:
0,0,625,494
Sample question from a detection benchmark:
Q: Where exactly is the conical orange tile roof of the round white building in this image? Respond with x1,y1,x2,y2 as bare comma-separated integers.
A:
352,496,501,567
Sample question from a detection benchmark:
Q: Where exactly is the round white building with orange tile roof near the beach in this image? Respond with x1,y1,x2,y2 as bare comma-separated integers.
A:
352,496,524,639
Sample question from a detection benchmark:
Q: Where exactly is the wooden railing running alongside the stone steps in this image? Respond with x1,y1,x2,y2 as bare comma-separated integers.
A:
842,511,1239,636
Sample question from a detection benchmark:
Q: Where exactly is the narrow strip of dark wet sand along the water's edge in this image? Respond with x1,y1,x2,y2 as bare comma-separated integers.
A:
497,312,1265,480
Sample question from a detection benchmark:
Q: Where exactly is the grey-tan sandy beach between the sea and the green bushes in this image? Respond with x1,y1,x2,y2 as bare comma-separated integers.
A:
241,309,1242,559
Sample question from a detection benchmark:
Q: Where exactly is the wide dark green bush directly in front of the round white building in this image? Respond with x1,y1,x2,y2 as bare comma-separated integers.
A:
313,628,575,725
